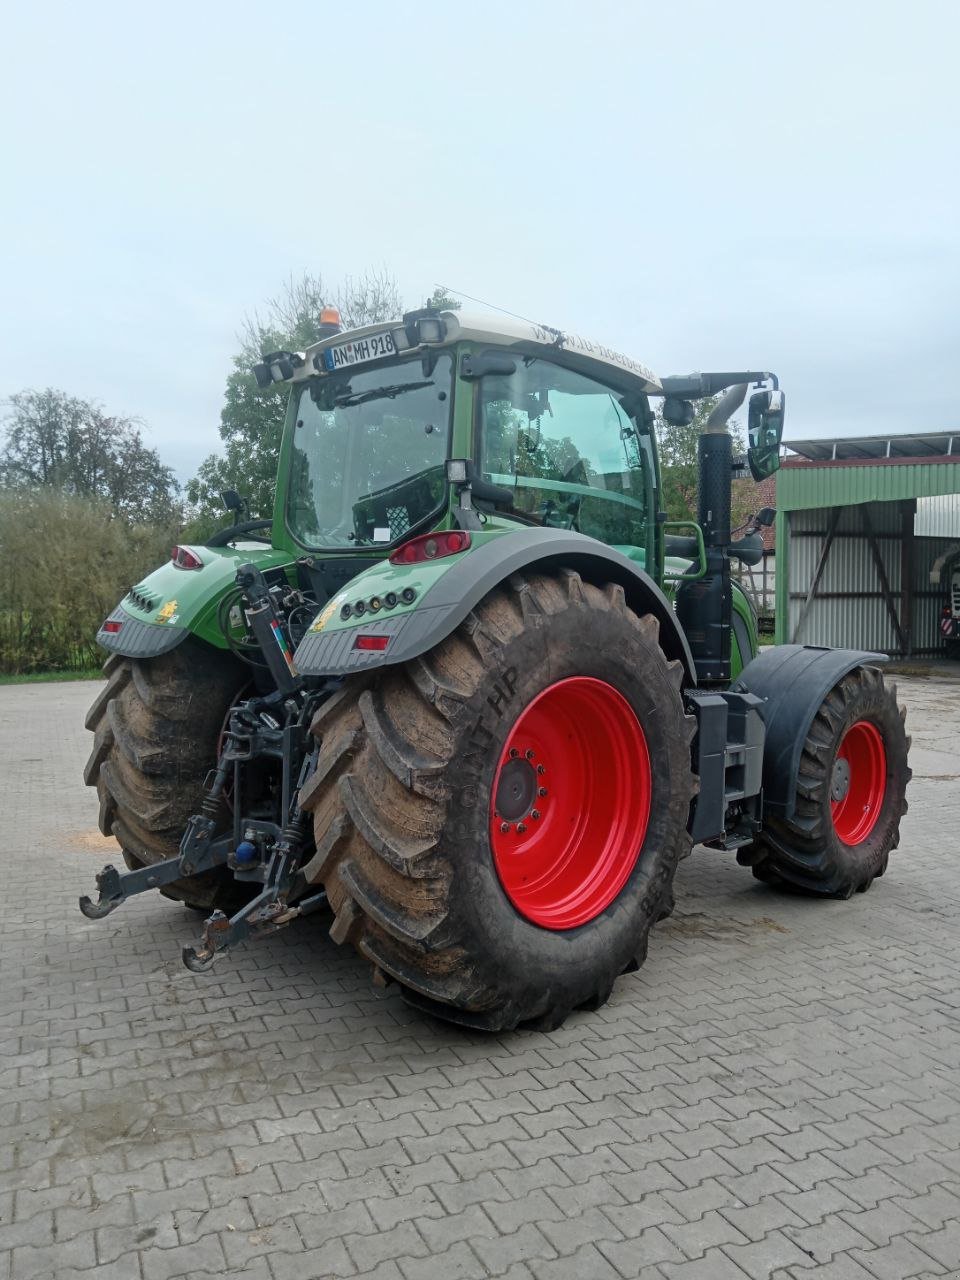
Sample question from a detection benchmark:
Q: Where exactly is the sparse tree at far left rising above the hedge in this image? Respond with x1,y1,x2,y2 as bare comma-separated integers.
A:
0,387,179,524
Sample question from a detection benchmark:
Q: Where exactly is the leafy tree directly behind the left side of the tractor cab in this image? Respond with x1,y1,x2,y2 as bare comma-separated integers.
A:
187,270,402,536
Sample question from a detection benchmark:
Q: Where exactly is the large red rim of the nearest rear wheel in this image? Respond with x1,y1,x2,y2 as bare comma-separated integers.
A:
490,676,652,929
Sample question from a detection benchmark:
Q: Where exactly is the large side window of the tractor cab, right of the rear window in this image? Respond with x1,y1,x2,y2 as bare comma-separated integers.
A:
480,358,653,548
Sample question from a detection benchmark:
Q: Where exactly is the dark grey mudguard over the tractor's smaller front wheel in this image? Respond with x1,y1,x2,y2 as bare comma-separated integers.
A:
731,644,887,818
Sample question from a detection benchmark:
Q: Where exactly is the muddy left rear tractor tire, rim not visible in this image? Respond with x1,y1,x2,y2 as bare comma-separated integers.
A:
83,637,246,909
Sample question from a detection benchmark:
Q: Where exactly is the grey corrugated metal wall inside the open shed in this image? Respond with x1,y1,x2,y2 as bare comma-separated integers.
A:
782,502,955,654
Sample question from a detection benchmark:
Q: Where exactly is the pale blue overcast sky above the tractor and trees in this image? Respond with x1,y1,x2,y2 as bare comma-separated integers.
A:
0,0,960,479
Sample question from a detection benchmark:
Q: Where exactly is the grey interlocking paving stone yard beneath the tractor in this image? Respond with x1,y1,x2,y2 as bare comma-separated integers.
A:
0,678,960,1280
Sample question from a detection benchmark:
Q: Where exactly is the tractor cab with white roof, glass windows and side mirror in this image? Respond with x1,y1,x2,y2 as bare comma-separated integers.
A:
261,308,782,601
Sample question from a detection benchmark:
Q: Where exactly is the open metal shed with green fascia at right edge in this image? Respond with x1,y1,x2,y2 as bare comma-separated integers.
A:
776,431,960,657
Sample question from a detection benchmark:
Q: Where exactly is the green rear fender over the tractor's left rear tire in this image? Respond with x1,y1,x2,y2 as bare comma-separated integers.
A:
97,543,293,658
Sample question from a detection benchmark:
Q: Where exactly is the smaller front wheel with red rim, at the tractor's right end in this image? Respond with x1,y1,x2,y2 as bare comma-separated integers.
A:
737,667,910,899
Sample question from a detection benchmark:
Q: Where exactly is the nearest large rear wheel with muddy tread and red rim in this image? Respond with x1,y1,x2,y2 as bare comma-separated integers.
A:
301,572,695,1029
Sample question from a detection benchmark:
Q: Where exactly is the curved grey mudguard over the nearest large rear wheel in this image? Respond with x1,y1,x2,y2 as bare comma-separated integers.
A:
293,529,696,685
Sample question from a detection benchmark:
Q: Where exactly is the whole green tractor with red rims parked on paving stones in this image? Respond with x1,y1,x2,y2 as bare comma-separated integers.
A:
81,308,910,1029
